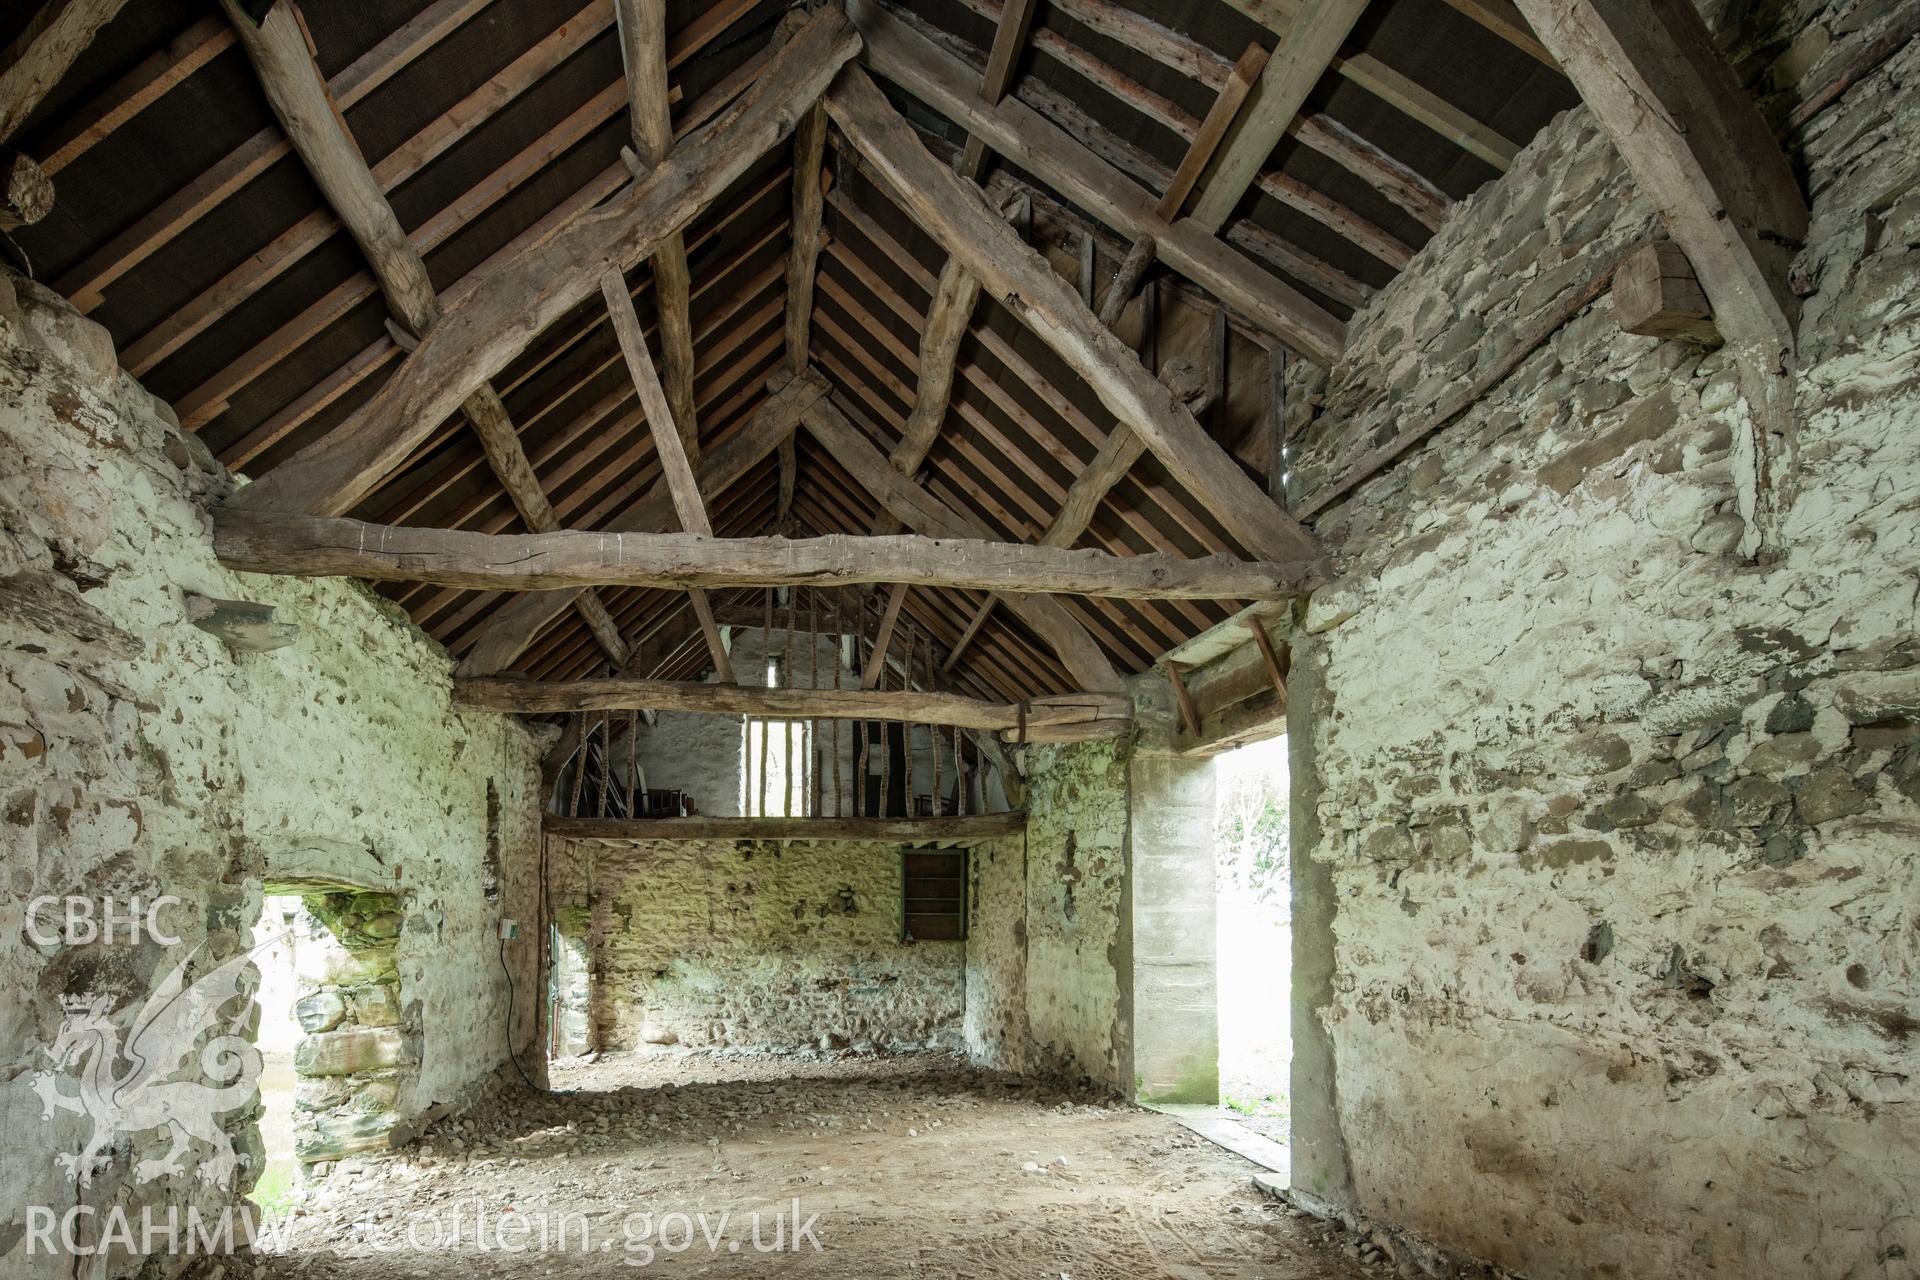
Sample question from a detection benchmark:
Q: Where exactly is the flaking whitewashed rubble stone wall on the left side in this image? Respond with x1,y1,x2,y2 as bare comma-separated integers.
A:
0,273,540,1276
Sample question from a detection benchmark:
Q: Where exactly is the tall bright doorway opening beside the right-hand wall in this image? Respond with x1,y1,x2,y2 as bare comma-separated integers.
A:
1213,737,1294,1144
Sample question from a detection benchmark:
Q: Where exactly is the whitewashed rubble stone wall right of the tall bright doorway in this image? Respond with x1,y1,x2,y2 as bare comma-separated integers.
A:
1292,6,1920,1278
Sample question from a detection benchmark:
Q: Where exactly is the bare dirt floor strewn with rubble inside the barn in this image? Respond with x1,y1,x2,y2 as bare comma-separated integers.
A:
255,1054,1392,1280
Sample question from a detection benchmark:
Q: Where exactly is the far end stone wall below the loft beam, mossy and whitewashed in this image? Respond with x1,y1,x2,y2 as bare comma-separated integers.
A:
551,841,966,1052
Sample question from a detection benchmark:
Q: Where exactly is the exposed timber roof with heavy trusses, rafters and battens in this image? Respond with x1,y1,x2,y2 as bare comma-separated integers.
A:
0,0,1681,706
